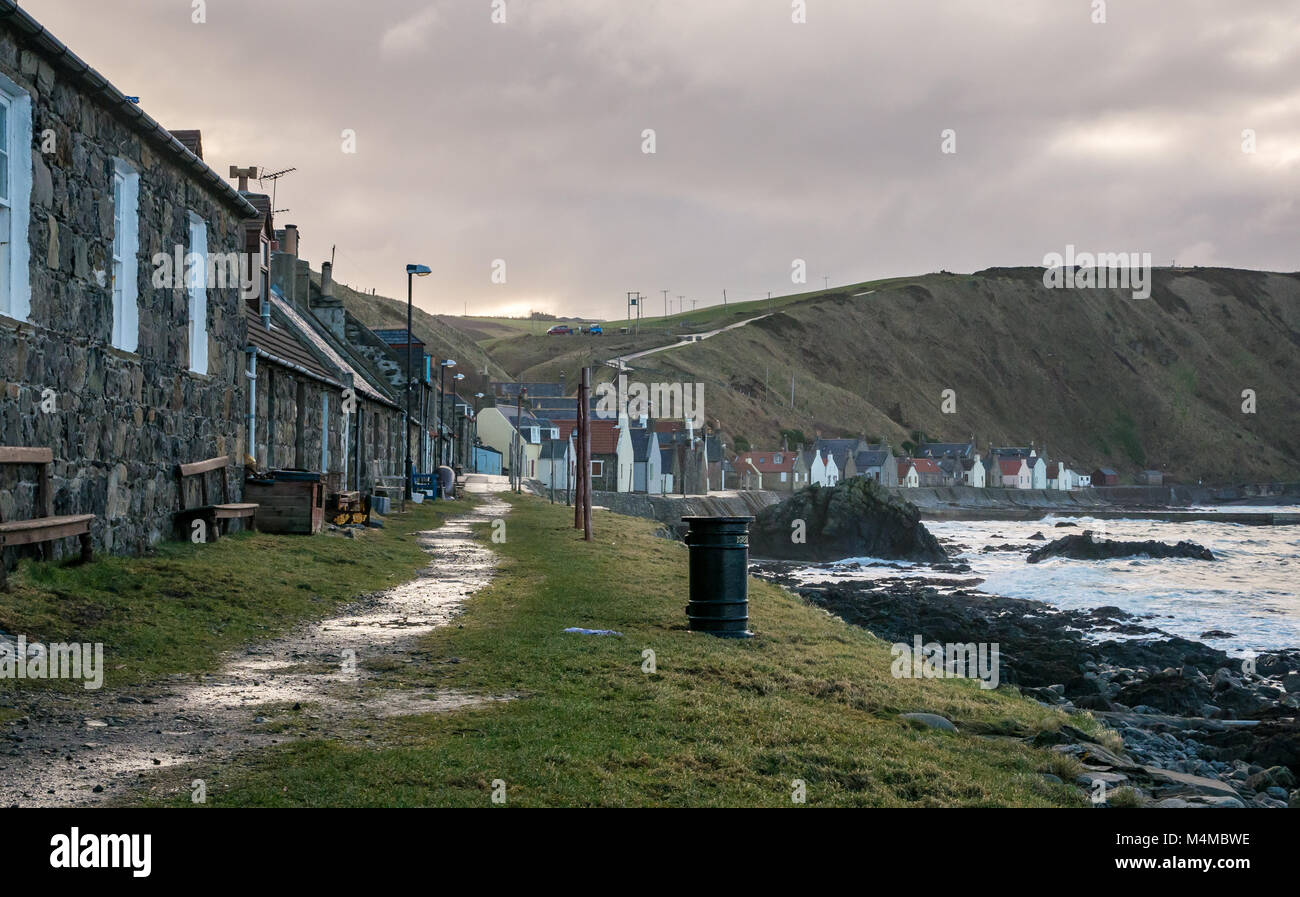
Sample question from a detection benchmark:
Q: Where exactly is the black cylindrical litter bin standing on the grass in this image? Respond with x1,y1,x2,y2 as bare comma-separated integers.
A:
681,517,754,638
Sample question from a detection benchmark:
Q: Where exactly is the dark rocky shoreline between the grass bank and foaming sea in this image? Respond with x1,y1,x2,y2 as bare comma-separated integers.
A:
750,560,1300,807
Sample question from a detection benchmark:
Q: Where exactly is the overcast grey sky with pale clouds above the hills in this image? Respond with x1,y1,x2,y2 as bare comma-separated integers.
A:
22,0,1300,316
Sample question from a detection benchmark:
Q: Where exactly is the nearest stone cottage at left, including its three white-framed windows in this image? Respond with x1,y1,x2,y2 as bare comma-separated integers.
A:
0,0,257,553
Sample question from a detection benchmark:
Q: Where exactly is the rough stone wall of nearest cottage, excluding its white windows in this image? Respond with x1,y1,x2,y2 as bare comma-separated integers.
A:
0,25,247,553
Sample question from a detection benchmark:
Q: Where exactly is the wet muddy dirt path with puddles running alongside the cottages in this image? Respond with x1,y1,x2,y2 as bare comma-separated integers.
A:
0,486,510,807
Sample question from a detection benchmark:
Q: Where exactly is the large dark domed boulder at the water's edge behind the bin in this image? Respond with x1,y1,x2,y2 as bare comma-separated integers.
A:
750,477,948,563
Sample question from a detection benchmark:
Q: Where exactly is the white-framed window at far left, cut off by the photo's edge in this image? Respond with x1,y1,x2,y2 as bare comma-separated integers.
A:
0,75,31,321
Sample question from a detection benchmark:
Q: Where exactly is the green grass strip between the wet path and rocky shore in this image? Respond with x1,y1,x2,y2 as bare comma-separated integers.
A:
142,497,1096,806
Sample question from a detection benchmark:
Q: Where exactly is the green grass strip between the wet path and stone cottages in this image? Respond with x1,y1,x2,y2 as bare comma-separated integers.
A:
0,502,464,697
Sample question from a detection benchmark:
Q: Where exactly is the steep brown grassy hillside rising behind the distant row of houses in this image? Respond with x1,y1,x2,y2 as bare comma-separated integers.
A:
611,268,1300,484
